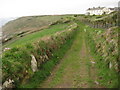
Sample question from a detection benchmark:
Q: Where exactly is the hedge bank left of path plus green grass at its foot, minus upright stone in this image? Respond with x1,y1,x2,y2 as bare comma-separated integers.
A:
2,23,77,87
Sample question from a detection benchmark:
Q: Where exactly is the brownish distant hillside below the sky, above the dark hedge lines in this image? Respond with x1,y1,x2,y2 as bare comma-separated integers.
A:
2,15,68,37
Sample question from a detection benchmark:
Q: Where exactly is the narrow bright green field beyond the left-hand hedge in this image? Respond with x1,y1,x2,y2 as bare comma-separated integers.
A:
5,23,69,47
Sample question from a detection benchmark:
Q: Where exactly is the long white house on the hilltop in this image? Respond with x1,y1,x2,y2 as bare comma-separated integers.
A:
86,7,115,15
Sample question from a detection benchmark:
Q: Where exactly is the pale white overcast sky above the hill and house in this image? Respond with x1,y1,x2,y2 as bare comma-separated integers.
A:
0,0,119,18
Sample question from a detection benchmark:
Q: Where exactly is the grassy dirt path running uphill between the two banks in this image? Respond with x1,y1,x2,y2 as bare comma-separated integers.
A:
39,23,100,88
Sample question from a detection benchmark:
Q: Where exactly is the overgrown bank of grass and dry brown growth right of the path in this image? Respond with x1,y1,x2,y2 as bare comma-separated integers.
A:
86,27,120,88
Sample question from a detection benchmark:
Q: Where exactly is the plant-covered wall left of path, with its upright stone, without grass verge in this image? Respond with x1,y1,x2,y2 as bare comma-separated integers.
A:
2,23,77,87
